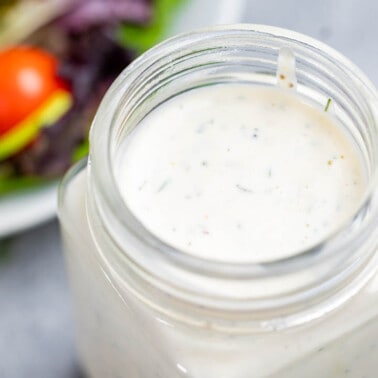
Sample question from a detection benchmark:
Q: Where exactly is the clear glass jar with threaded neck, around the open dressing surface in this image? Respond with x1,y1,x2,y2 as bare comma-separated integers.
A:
59,25,378,378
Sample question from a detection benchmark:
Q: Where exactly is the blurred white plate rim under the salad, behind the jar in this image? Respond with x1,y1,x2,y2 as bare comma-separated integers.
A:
0,0,246,238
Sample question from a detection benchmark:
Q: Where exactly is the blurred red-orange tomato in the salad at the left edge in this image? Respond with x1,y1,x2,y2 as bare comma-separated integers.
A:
0,46,67,135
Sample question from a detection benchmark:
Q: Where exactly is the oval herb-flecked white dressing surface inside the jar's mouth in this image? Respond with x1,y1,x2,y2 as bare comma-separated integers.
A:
118,84,365,262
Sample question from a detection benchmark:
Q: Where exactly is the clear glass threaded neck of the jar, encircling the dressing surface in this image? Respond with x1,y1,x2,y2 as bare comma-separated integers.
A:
88,25,378,331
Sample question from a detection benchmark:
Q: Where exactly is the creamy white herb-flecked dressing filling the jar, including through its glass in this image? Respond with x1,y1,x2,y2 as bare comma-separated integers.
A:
60,30,378,378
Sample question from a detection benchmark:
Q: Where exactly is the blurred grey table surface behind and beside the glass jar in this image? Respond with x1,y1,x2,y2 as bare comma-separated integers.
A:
0,0,378,378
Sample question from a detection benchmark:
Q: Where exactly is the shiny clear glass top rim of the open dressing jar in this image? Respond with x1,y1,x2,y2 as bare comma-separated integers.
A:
90,24,378,279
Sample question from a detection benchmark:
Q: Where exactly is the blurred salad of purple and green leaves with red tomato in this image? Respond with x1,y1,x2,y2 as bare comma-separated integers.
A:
0,0,185,197
